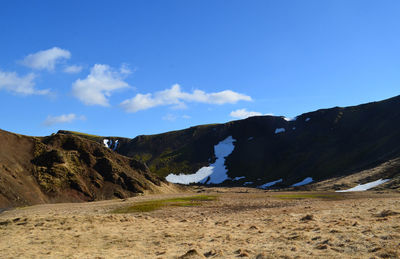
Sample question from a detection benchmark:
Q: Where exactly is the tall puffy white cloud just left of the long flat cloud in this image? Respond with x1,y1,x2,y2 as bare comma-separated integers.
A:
72,64,129,106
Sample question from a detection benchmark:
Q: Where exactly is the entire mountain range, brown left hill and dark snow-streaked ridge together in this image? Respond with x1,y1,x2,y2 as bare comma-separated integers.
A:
0,96,400,208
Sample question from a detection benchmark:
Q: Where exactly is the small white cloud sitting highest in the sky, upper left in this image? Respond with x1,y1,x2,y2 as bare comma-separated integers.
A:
22,47,71,71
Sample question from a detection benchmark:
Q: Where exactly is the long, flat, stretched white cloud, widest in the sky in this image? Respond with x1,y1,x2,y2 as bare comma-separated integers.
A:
121,84,252,112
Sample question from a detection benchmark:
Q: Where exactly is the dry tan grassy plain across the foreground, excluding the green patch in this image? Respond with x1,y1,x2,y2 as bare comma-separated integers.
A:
0,188,400,259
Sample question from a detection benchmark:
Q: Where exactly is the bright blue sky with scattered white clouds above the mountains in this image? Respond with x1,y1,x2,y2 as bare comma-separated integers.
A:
0,0,400,137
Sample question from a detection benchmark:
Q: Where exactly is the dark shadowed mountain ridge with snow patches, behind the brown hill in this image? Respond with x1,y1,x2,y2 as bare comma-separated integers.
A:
60,96,400,191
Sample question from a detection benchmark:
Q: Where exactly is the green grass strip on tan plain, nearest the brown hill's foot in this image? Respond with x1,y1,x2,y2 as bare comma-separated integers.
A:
112,195,217,213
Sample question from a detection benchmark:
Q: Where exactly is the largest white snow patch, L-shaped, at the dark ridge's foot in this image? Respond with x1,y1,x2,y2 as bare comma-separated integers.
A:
165,136,235,184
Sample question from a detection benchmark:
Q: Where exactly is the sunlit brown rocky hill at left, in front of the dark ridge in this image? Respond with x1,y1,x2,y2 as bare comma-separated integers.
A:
0,130,174,208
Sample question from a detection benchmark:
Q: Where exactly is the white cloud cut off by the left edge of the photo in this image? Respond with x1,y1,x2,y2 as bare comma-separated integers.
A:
0,70,50,95
